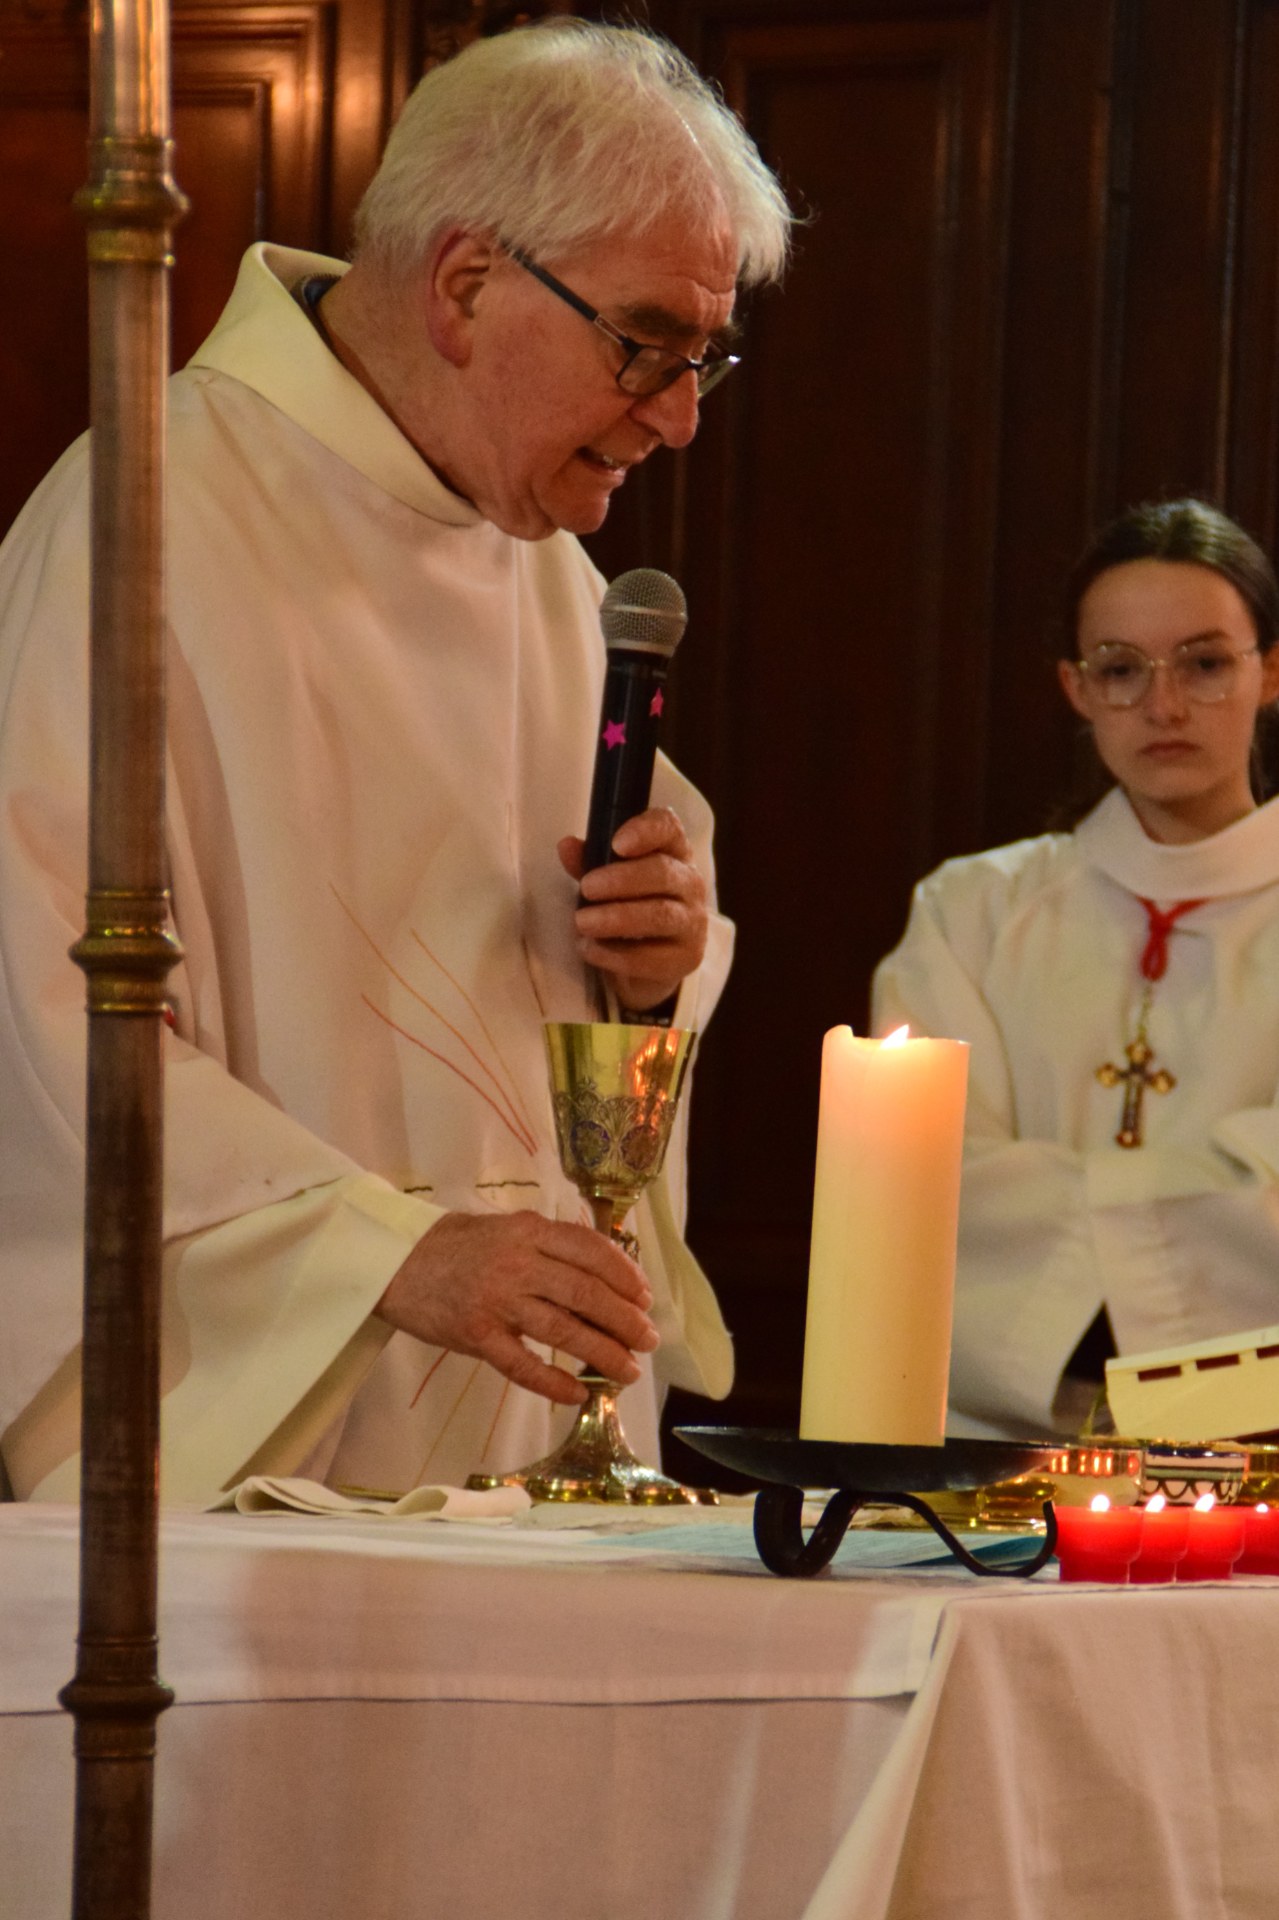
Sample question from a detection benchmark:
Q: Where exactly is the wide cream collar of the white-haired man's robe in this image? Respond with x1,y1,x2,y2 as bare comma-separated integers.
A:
180,242,484,526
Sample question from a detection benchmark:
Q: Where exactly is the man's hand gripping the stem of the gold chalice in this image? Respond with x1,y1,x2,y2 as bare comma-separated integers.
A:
374,1213,657,1405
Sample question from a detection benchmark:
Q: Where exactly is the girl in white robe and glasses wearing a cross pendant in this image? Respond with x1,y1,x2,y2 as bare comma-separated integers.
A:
874,499,1279,1434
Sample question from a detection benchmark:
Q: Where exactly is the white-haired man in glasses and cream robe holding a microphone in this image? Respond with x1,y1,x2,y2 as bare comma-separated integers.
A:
0,21,789,1501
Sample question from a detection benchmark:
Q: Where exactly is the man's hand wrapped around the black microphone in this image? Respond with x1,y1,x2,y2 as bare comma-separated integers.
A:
559,806,707,1014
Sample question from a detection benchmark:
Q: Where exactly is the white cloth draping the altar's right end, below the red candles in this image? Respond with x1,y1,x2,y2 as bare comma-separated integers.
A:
803,1576,1279,1920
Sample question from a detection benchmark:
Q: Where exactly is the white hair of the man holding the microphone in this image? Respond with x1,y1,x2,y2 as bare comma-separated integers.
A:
355,15,791,286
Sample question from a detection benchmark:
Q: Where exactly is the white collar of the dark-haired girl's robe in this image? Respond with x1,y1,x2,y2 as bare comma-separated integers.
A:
1075,787,1279,902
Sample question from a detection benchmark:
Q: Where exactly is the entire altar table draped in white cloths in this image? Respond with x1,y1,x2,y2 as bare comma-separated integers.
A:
0,1505,1279,1920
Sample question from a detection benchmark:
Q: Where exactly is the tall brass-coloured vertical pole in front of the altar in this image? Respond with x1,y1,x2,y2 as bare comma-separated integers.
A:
60,0,186,1920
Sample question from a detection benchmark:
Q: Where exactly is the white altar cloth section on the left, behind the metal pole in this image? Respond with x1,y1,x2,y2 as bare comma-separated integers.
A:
0,1505,945,1920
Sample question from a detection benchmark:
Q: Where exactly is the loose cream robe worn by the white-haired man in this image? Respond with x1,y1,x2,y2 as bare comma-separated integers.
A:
0,246,732,1501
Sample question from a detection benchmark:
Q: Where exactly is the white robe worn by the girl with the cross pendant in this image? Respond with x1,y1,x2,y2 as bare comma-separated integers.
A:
874,789,1279,1432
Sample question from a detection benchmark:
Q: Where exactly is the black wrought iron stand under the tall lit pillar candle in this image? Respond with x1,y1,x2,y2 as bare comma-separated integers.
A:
676,1427,1062,1578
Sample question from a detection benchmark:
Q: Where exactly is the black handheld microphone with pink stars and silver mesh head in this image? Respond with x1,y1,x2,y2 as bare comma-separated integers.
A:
582,566,688,874
